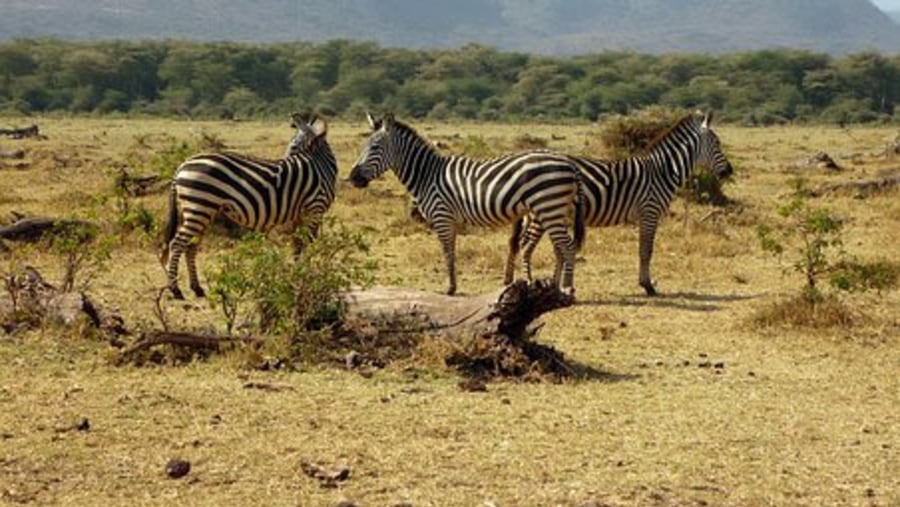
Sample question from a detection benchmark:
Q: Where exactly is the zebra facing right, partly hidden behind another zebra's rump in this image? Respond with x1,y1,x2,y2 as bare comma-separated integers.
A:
505,114,732,296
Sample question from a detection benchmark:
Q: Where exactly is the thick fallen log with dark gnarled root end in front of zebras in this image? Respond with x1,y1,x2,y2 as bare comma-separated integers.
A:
342,280,576,380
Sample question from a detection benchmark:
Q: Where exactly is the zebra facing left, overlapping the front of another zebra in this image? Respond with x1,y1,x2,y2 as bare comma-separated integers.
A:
350,114,584,295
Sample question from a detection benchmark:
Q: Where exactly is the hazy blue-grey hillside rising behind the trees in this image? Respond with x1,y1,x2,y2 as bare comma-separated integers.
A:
0,0,900,55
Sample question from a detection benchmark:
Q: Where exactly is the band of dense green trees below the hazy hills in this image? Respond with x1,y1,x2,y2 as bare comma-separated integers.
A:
0,39,900,124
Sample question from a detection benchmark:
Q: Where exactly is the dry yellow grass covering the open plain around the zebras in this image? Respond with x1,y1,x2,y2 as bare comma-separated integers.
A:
0,118,900,506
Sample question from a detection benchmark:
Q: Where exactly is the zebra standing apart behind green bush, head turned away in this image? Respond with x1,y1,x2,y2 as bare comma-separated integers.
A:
160,113,337,299
